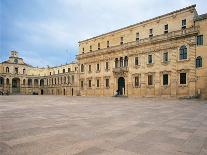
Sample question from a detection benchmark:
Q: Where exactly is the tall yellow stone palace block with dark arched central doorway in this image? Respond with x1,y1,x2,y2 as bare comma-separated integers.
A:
77,5,207,97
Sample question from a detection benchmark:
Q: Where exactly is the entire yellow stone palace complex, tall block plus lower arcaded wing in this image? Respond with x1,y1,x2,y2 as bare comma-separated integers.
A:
0,5,207,98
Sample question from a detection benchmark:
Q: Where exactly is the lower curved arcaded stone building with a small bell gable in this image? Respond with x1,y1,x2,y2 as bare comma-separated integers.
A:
0,51,79,96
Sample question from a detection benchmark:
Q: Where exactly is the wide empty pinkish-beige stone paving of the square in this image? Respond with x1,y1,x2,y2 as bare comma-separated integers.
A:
0,96,207,155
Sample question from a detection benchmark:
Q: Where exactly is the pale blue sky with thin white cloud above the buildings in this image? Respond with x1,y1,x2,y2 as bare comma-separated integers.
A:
0,0,207,67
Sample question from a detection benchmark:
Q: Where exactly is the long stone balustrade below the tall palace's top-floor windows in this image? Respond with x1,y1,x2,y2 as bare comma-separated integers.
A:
76,27,199,59
